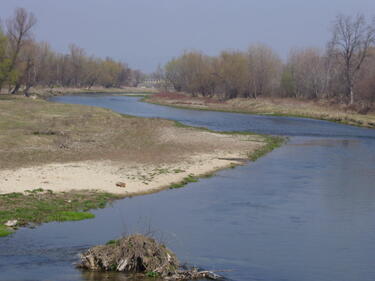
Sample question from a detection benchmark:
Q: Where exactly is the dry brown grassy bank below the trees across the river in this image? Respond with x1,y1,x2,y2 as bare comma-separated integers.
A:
147,94,375,128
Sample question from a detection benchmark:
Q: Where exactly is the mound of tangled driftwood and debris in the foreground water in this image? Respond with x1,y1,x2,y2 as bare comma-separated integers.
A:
78,234,221,280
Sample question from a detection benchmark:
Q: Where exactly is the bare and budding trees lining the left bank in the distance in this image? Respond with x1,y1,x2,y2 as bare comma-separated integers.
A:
0,8,144,95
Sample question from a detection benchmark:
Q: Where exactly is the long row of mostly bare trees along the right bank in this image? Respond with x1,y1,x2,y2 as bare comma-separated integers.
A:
164,15,375,106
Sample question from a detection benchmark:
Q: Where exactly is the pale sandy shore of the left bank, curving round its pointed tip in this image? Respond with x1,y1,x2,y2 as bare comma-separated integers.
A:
0,128,265,195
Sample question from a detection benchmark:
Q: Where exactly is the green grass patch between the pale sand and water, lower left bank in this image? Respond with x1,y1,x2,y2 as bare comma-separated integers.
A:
0,189,121,237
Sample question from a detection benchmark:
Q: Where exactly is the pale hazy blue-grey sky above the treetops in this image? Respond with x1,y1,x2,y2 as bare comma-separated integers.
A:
0,0,375,72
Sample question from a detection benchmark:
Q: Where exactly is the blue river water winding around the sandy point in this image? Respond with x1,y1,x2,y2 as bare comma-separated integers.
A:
0,95,375,281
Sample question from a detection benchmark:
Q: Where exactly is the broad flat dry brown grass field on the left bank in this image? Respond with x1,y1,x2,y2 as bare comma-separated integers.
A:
0,95,217,169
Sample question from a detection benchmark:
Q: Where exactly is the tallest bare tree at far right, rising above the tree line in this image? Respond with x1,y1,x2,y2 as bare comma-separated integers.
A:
329,15,375,104
